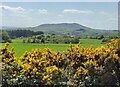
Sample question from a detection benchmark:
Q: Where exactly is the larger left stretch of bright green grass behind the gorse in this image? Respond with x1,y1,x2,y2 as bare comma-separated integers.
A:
9,43,68,57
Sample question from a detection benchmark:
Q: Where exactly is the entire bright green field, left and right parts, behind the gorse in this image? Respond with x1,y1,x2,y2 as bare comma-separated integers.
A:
0,39,106,58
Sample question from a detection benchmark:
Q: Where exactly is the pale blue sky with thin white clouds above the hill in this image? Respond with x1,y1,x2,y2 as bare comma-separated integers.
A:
0,2,118,30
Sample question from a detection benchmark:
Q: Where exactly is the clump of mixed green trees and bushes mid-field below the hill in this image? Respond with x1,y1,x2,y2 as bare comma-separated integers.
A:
24,34,79,44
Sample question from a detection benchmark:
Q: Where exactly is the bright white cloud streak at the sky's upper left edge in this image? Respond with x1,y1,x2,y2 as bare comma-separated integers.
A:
0,5,25,13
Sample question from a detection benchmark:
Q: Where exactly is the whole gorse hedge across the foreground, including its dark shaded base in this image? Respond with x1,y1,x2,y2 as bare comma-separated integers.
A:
1,39,120,87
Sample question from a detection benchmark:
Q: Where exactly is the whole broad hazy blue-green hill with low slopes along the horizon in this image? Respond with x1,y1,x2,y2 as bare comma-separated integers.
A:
1,23,118,37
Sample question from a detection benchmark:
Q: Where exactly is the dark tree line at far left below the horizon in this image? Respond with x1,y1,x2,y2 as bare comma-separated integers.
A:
0,30,44,42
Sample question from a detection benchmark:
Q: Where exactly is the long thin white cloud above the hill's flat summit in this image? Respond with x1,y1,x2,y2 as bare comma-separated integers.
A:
63,9,94,14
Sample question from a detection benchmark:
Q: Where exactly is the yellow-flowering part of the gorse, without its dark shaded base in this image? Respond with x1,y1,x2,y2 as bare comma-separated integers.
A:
1,39,120,84
